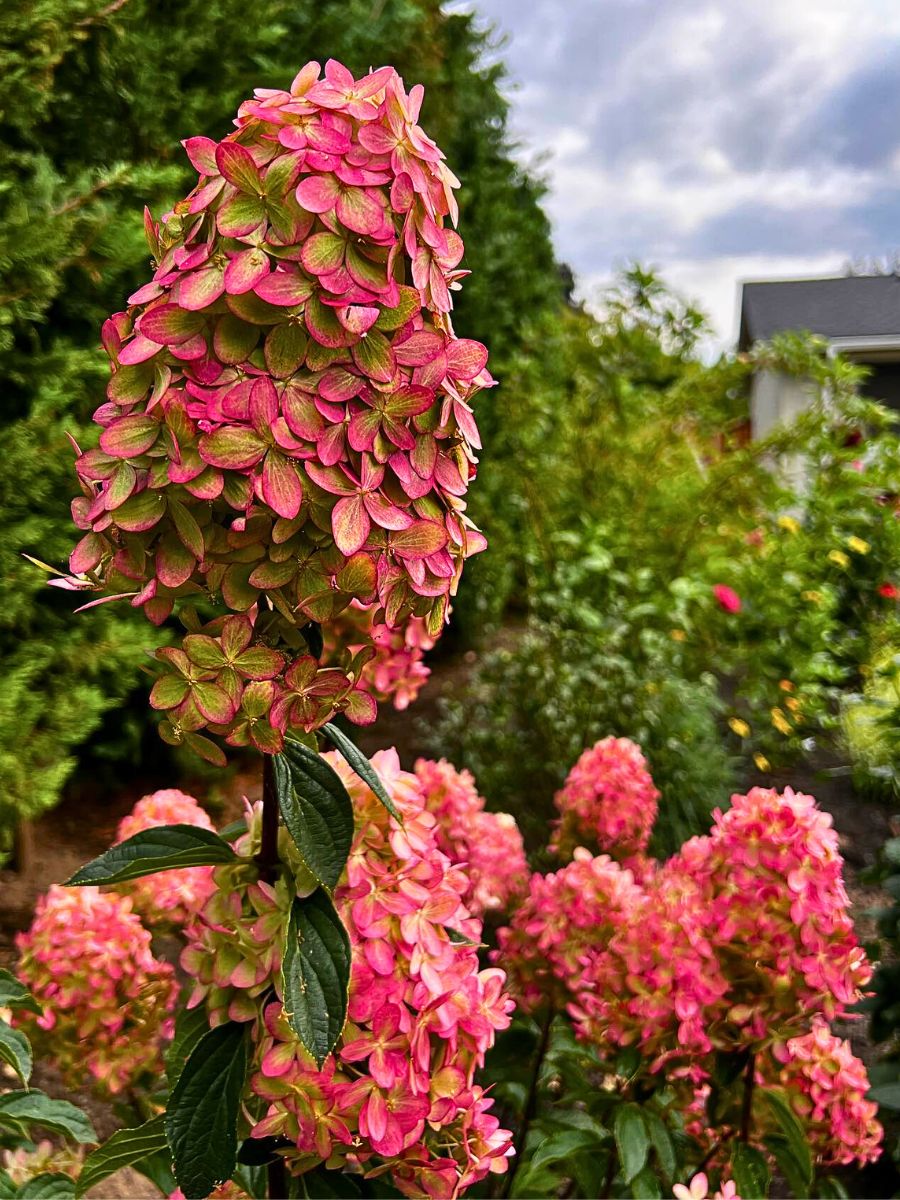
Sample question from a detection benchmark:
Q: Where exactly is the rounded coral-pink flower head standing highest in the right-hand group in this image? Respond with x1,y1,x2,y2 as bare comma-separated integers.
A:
551,737,659,860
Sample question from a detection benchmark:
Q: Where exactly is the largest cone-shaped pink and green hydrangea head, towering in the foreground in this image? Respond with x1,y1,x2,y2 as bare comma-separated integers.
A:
62,61,493,757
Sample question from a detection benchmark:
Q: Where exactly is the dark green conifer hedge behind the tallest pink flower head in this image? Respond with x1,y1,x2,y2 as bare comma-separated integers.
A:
0,0,562,827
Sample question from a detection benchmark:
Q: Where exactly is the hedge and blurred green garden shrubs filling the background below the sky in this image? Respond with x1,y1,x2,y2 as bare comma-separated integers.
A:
0,0,900,851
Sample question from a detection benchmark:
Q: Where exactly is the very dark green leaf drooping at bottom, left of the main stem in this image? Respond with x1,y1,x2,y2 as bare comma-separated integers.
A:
166,1021,248,1200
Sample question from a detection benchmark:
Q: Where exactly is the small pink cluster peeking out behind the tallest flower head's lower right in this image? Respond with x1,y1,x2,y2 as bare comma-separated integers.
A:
323,600,437,713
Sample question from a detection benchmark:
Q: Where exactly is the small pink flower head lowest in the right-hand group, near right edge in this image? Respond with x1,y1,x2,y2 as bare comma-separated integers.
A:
773,1021,883,1166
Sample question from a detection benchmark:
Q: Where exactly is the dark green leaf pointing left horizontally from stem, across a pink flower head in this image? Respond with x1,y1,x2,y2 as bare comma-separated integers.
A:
66,824,238,888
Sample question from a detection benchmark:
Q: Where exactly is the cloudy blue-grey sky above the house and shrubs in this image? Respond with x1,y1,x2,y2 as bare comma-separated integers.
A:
455,0,900,344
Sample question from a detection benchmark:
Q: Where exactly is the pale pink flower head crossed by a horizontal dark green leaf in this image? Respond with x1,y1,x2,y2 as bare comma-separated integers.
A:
115,787,215,926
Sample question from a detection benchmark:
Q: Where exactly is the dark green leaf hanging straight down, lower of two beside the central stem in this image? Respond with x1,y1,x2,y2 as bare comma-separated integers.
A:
281,888,350,1067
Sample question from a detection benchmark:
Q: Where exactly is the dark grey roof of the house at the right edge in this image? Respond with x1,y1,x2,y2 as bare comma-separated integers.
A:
738,275,900,350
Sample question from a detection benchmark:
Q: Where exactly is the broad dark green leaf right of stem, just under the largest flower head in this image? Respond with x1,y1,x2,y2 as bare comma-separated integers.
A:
274,742,353,892
